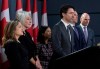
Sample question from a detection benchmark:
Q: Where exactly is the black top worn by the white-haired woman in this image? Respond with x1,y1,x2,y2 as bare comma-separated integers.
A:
19,31,37,69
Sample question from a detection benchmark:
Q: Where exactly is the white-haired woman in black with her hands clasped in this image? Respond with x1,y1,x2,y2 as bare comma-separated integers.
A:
16,11,42,69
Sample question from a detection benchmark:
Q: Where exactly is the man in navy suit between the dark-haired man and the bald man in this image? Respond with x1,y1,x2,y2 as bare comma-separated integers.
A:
70,11,86,51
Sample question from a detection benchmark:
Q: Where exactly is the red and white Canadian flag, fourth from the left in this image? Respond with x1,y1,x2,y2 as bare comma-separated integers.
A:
33,0,39,44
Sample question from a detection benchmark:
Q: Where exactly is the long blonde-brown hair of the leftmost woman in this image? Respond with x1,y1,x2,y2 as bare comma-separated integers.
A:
2,20,19,46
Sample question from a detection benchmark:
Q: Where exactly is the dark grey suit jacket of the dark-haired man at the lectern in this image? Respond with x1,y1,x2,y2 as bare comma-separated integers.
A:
52,21,73,59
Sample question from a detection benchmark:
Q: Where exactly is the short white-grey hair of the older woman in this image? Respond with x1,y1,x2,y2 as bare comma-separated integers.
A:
16,11,31,25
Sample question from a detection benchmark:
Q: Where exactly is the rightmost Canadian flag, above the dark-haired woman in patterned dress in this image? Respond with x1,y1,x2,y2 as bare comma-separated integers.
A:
41,0,48,26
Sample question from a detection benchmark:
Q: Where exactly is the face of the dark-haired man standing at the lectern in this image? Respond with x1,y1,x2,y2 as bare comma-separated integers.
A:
63,8,75,22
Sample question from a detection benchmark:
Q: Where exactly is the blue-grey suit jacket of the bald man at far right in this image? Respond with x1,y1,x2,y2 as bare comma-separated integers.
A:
77,25,95,47
